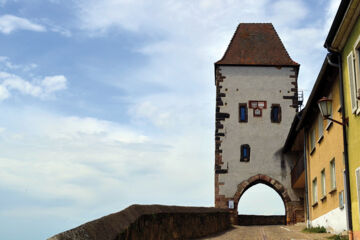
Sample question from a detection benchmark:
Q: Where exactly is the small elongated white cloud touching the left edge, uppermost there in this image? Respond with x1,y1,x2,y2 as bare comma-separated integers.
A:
0,14,46,34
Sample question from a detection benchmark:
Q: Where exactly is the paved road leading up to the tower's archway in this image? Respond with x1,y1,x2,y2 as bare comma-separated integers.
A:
199,226,331,240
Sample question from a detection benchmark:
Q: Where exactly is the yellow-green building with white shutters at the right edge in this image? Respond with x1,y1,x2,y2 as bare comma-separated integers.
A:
325,0,360,240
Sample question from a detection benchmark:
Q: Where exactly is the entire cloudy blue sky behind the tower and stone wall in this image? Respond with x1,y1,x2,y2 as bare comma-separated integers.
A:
0,0,340,240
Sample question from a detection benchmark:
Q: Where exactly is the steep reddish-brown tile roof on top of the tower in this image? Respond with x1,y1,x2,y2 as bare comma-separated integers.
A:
215,23,299,66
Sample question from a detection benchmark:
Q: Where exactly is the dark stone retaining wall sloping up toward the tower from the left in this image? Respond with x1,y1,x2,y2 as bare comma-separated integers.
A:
48,205,231,240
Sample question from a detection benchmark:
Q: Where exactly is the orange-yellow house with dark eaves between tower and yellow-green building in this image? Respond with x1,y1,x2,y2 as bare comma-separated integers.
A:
289,58,347,233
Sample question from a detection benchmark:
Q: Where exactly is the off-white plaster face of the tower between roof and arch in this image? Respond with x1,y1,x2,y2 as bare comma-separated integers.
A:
219,66,299,201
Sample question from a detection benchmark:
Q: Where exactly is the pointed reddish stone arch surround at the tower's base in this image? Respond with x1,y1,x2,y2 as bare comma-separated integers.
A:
231,174,303,224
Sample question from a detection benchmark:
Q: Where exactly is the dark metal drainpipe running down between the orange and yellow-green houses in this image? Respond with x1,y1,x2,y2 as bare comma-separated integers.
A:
327,51,353,235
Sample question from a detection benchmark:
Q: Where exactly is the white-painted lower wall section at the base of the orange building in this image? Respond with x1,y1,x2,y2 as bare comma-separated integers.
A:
311,207,347,234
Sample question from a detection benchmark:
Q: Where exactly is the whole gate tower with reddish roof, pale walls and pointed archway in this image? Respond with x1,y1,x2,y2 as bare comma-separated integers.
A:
215,23,304,224
